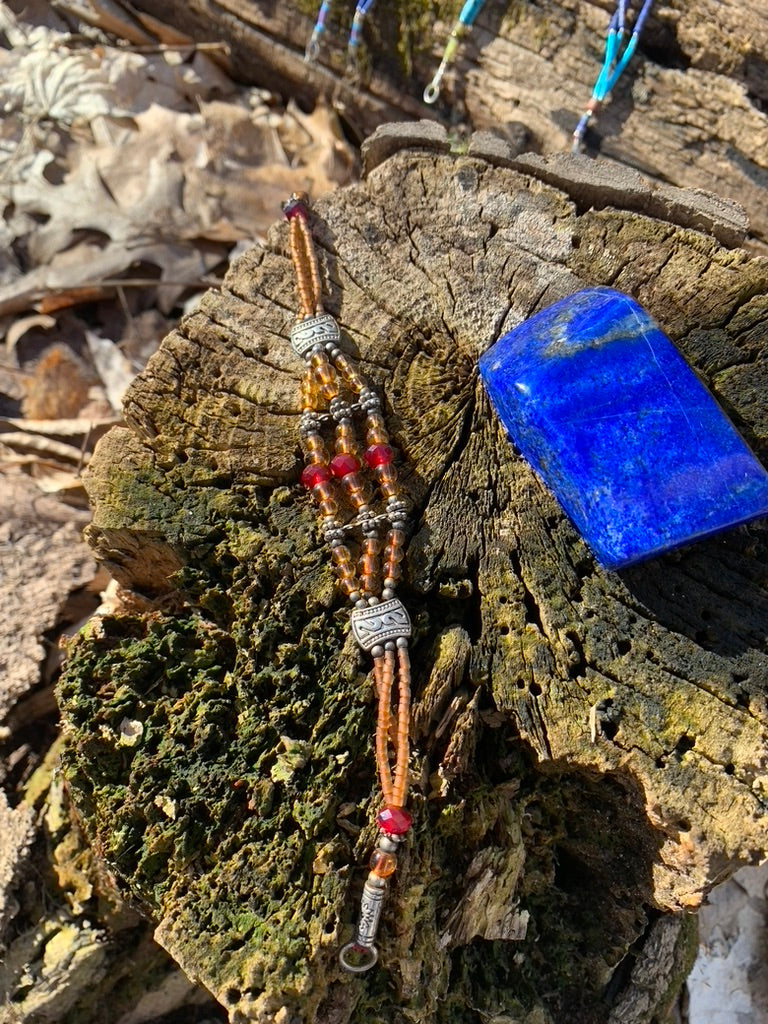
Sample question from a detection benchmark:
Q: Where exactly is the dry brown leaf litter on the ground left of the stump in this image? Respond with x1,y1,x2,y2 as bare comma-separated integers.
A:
0,8,357,1007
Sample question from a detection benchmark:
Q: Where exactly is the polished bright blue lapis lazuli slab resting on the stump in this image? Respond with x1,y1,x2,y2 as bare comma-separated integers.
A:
479,288,768,569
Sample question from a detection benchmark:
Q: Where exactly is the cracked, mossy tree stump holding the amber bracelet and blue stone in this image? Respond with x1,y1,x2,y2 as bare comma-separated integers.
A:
59,126,768,1024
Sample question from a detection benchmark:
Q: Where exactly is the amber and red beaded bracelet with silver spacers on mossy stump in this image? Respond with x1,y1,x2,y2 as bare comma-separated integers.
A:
283,193,411,973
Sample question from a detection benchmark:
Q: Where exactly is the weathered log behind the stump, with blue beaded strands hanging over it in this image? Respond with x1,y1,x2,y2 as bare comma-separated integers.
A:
126,0,768,251
